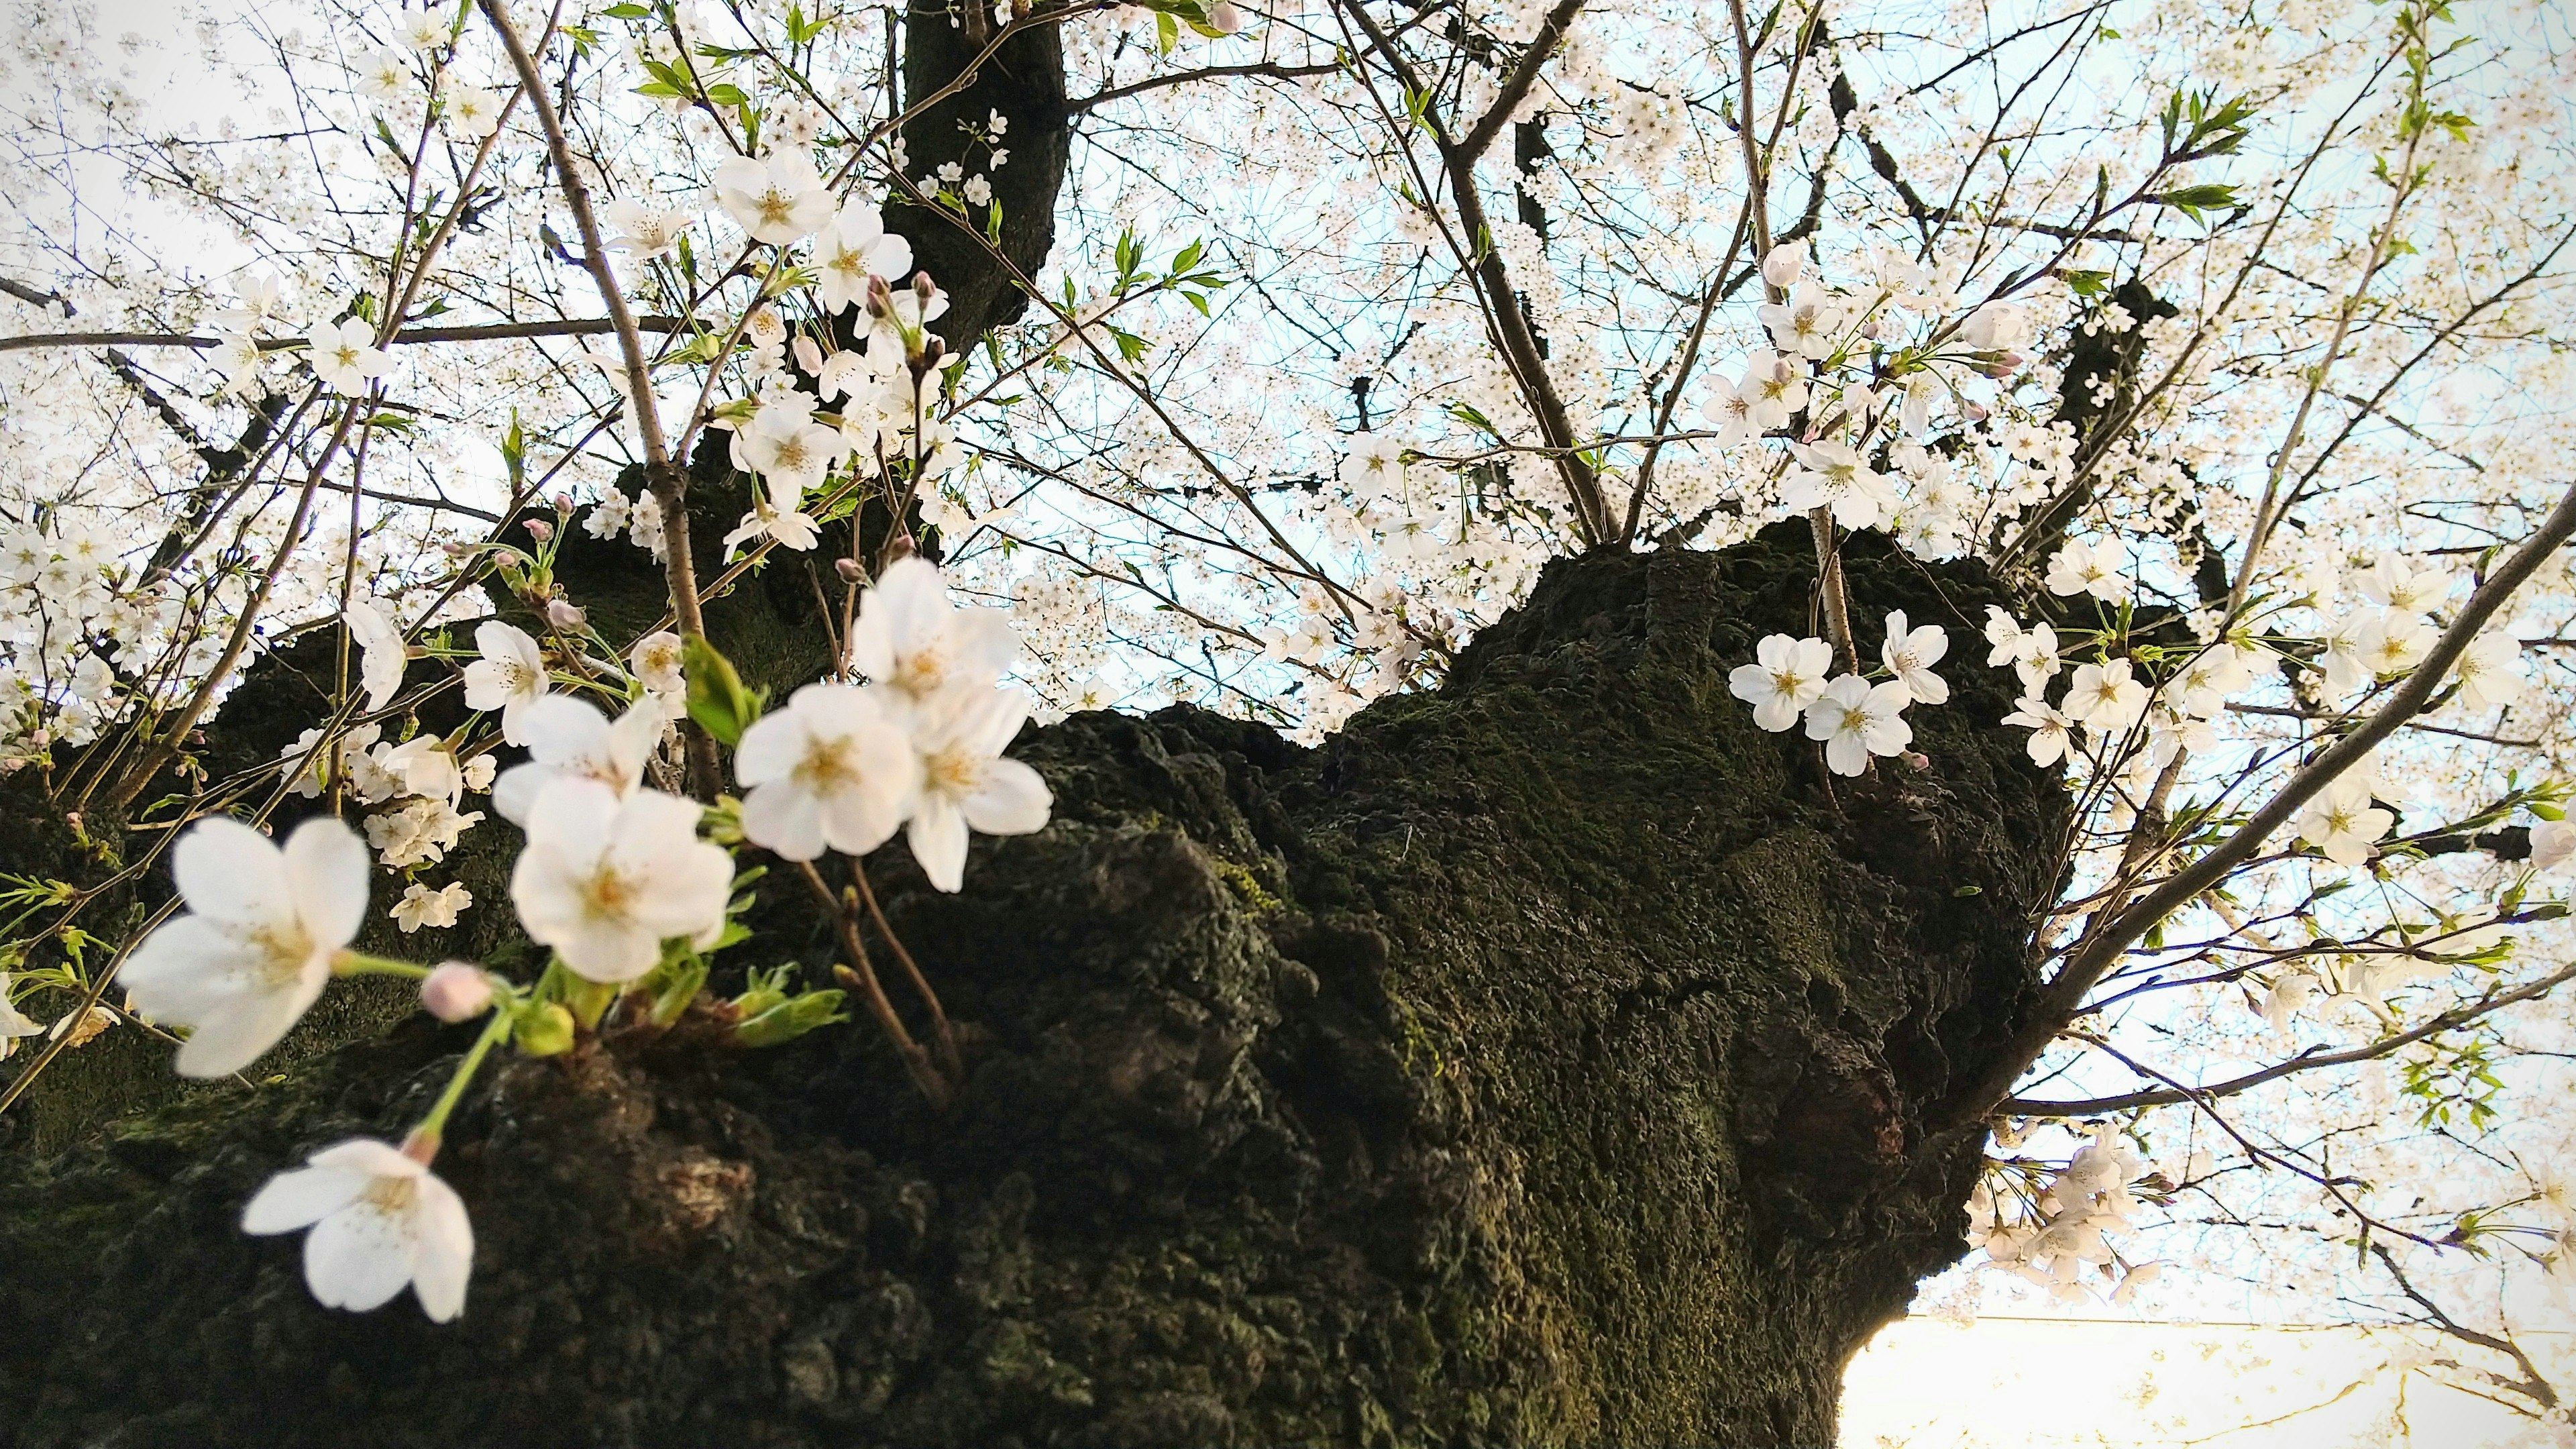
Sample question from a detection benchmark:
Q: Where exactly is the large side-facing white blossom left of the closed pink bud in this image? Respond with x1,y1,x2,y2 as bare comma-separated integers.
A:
116,817,366,1078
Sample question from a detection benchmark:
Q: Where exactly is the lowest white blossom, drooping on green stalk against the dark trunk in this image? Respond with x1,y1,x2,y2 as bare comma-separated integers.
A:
242,1137,474,1323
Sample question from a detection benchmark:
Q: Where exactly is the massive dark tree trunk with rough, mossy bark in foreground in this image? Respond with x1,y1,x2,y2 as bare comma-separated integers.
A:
0,526,2066,1449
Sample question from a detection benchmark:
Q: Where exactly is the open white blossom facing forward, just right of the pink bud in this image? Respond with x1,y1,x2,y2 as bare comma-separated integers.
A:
510,779,734,982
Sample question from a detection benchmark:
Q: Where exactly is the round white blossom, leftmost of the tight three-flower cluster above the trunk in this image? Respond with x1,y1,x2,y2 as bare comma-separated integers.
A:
734,684,922,861
